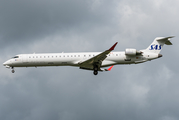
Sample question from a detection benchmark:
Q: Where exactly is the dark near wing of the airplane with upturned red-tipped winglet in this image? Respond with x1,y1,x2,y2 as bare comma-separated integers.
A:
80,42,117,71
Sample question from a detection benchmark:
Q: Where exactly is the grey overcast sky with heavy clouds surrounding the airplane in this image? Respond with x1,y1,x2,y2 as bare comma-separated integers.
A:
0,0,179,120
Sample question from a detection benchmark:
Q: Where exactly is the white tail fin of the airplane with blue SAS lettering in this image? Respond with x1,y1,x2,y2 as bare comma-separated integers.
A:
144,36,174,54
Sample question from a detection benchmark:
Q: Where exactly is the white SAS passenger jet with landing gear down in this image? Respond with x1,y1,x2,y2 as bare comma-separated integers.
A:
3,36,174,75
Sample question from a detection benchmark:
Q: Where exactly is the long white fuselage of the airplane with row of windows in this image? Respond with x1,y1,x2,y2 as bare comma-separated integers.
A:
4,52,159,67
